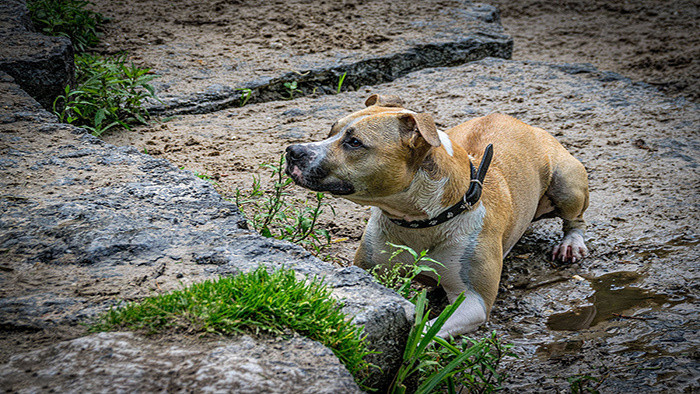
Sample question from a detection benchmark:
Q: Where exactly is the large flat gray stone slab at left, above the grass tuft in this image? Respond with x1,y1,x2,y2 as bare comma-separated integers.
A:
0,71,413,386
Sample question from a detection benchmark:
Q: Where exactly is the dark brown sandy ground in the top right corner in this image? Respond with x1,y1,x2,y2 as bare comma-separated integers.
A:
488,0,700,100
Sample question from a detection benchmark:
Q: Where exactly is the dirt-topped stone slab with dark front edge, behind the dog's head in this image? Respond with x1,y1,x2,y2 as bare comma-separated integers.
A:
90,0,513,115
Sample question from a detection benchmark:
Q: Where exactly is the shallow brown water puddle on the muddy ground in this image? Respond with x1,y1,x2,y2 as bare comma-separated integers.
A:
547,271,685,331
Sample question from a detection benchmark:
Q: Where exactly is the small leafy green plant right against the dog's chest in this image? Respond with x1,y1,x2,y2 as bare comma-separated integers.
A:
370,242,443,302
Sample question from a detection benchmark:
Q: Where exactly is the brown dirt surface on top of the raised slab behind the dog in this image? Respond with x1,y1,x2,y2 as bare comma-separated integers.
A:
96,0,508,97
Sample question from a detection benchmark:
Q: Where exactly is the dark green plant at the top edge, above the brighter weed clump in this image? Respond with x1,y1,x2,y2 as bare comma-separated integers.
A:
27,0,106,53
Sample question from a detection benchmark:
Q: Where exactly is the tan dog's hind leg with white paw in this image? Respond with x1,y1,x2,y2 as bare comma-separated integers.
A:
545,156,588,263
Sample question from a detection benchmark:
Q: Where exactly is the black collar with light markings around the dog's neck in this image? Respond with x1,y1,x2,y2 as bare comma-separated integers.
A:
389,144,493,228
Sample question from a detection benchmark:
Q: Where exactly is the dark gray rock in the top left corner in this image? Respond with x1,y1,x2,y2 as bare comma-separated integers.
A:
0,0,75,110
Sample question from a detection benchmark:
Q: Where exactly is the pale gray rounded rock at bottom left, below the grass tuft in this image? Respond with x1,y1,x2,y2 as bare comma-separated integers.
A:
0,332,361,394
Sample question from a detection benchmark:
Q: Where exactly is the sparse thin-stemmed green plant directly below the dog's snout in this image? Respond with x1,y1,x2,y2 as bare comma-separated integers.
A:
235,155,335,256
